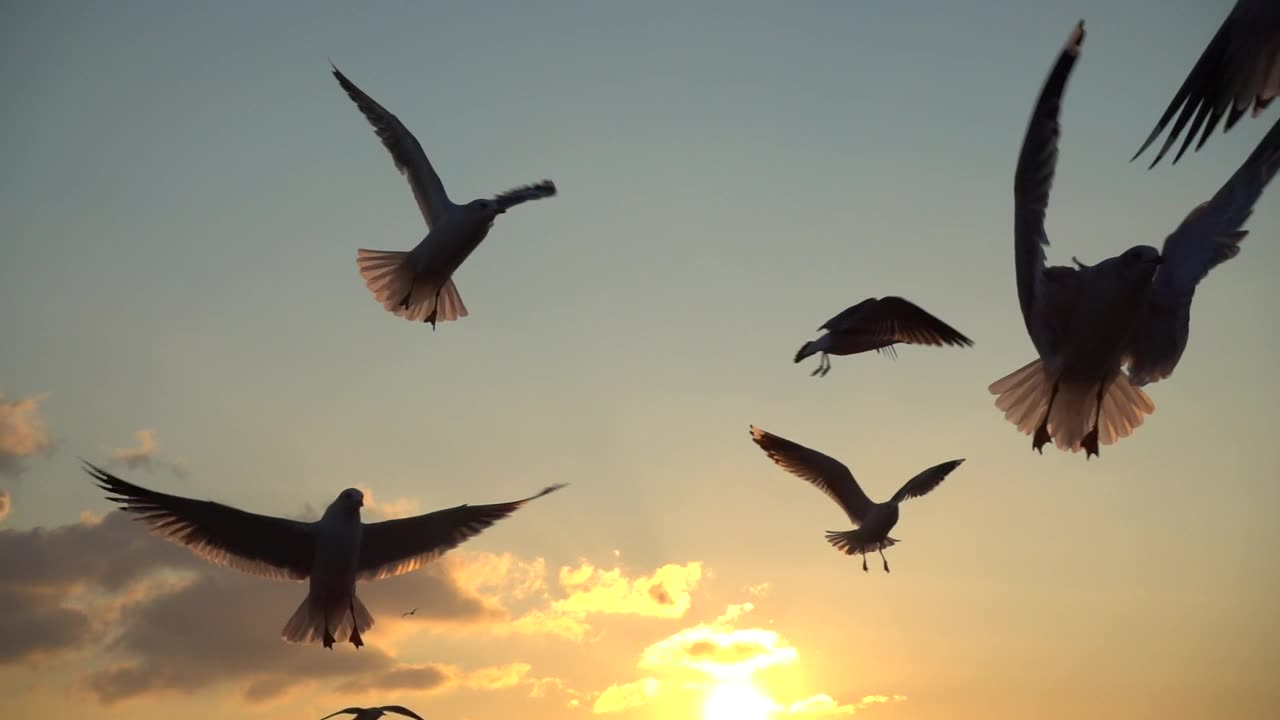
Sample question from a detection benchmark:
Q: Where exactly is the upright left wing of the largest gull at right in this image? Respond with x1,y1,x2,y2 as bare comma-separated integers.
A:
1014,20,1084,356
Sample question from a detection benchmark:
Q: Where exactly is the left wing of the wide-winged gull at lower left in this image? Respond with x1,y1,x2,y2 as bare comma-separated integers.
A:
84,462,315,580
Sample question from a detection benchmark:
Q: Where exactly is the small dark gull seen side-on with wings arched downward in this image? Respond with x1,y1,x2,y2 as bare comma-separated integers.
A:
795,296,973,377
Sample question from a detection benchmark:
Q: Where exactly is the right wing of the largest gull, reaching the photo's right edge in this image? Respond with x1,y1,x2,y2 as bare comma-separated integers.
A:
1129,114,1280,386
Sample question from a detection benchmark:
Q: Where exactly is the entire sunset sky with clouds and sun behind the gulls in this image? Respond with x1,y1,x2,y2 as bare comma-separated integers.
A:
0,0,1280,720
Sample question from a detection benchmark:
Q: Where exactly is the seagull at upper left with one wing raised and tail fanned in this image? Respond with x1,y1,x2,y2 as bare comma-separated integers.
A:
329,63,556,329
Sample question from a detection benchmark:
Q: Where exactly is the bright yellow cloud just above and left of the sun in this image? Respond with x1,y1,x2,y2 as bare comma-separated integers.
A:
553,561,703,618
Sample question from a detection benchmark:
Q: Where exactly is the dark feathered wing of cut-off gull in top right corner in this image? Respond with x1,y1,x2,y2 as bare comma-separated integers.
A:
1129,0,1280,169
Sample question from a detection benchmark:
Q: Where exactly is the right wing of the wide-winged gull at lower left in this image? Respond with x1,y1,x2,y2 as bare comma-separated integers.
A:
356,484,564,580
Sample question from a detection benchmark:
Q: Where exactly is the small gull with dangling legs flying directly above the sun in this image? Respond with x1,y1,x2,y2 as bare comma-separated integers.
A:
751,425,964,573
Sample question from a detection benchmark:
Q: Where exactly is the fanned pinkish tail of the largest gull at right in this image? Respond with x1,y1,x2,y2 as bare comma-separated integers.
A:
987,360,1156,452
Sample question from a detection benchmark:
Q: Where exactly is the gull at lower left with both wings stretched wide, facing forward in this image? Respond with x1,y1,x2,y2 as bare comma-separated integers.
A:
82,460,564,650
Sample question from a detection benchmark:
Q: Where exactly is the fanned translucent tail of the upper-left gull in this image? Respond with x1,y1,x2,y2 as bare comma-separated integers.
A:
356,247,467,325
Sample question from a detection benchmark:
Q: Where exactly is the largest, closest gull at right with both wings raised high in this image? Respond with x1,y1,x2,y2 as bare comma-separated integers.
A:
988,22,1280,457
